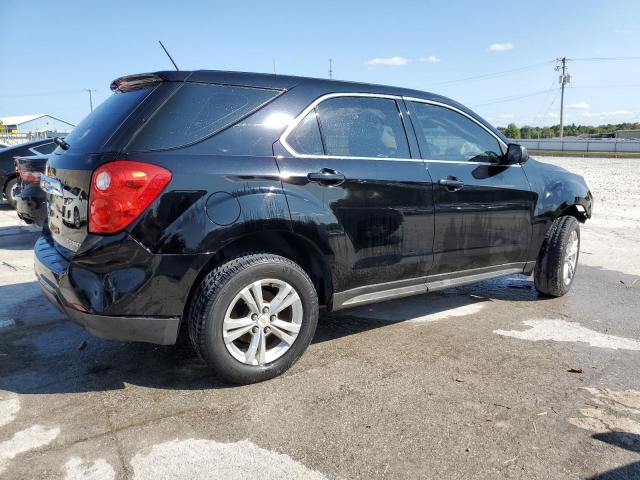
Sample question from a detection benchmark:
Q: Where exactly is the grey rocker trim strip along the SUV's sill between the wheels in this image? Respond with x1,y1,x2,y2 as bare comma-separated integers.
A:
331,262,532,311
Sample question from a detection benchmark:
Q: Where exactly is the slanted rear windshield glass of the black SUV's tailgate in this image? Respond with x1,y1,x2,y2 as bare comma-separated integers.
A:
64,87,153,153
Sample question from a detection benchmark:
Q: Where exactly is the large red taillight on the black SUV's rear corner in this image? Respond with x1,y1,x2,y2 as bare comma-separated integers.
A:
89,160,171,234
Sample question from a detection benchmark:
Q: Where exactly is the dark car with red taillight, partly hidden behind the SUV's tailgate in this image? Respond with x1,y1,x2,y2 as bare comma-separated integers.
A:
11,155,49,226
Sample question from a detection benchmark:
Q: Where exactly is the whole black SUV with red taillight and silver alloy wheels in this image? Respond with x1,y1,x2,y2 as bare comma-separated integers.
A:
35,71,592,383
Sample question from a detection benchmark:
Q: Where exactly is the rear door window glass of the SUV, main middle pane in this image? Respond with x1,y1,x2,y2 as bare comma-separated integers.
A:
317,97,411,158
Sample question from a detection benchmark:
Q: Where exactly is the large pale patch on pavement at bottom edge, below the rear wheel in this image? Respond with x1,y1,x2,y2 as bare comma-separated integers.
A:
131,439,325,480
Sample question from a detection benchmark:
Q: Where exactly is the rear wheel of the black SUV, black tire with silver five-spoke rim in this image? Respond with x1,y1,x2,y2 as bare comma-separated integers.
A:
189,253,318,384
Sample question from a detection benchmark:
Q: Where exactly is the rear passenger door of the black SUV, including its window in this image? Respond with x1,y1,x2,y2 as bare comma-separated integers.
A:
277,93,433,292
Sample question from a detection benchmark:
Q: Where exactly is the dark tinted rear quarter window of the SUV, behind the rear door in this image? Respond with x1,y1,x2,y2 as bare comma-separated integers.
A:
129,83,280,150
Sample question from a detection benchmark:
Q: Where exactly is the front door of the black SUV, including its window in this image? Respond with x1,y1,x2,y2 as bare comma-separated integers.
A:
405,99,535,275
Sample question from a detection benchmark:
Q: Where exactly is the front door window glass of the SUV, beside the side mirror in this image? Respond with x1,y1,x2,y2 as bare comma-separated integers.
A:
412,102,502,163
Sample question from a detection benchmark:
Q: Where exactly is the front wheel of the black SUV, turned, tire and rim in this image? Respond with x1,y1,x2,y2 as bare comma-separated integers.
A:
534,216,580,297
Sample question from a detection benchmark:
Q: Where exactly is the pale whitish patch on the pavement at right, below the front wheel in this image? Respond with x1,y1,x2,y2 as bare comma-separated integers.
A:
493,319,640,351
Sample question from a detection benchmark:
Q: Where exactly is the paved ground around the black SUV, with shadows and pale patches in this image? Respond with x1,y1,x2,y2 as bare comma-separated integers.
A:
0,158,640,479
